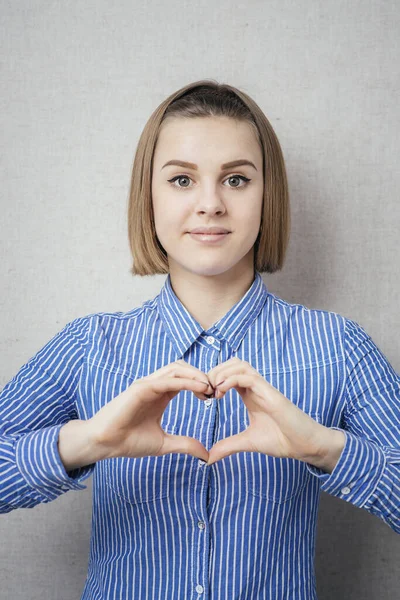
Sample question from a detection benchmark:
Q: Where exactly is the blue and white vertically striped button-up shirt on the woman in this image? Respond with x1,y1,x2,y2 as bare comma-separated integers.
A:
0,272,400,600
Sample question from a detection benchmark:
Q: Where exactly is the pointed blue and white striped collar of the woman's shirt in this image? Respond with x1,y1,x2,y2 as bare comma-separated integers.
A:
157,271,268,358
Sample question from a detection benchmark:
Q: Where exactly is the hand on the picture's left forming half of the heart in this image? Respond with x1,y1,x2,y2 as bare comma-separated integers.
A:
86,360,214,461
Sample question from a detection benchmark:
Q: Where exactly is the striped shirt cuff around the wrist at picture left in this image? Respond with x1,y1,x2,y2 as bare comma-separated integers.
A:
15,424,95,501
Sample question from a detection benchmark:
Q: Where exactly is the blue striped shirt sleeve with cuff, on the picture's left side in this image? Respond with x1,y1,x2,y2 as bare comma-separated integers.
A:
0,317,94,513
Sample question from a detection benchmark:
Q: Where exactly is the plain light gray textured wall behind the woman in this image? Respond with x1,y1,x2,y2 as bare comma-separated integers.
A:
0,0,400,600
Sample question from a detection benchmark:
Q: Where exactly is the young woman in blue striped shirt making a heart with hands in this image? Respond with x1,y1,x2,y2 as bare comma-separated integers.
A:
0,80,400,600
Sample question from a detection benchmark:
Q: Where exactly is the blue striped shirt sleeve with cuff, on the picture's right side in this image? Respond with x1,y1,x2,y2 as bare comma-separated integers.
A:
306,319,400,534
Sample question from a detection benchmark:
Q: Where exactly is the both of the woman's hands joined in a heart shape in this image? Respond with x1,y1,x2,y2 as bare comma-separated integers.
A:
79,358,344,469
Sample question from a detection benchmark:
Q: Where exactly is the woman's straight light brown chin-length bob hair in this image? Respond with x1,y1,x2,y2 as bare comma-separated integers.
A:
128,79,290,276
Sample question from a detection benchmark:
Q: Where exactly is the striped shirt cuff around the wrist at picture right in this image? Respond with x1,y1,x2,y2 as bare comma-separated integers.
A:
306,427,386,508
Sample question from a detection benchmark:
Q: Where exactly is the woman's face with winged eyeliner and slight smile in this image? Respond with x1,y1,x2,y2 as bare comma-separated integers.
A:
152,117,264,276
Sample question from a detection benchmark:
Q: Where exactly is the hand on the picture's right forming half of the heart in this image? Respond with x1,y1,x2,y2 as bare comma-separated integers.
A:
207,357,327,465
